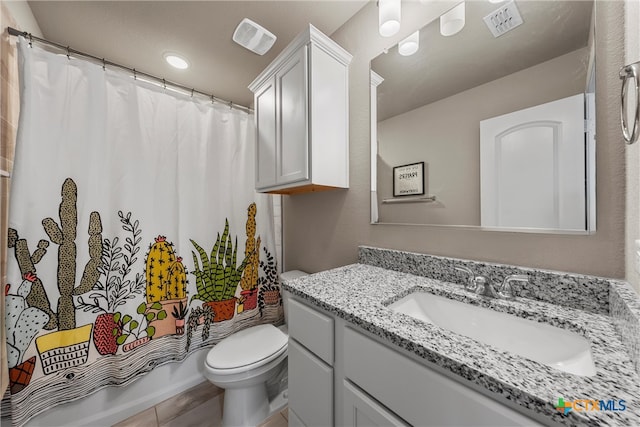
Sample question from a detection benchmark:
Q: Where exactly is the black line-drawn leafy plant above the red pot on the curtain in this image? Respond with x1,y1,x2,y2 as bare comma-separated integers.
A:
78,211,145,313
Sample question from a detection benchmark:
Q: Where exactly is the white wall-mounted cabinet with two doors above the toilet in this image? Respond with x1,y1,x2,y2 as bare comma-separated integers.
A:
249,25,351,194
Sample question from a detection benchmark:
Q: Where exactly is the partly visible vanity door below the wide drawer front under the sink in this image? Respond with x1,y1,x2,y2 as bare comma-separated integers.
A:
342,381,409,427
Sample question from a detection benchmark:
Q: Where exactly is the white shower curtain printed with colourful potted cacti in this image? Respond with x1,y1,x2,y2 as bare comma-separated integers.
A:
5,40,283,425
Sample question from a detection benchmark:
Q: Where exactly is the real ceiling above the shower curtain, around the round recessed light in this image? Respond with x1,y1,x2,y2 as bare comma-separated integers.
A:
28,0,367,106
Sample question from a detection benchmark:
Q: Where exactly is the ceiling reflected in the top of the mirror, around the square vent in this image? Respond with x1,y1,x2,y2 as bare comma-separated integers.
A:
372,0,594,121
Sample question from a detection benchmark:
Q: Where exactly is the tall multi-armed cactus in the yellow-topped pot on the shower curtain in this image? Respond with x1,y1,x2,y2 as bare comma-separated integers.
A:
27,178,102,331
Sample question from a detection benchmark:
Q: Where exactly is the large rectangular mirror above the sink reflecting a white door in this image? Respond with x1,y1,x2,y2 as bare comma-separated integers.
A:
371,0,595,234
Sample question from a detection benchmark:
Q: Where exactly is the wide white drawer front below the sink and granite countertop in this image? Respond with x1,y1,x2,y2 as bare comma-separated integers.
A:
344,327,539,426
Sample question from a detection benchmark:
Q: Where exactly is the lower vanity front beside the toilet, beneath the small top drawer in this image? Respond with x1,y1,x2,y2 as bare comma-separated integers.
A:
288,338,333,426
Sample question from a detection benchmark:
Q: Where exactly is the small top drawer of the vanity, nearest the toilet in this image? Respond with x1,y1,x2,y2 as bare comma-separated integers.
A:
287,299,333,365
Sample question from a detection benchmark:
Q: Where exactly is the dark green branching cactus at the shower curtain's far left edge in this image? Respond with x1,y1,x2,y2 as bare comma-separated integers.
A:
7,228,56,330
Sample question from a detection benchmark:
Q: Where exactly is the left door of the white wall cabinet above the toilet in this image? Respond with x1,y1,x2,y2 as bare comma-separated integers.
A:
255,78,276,189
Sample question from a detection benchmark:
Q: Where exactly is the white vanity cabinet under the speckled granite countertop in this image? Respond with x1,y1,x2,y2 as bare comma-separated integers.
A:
288,298,542,427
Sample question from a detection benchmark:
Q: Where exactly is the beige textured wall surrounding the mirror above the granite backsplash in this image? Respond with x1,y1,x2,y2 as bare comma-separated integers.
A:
284,1,624,278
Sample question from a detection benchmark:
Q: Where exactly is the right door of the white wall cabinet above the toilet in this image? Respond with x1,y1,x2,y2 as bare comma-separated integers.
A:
276,46,309,185
